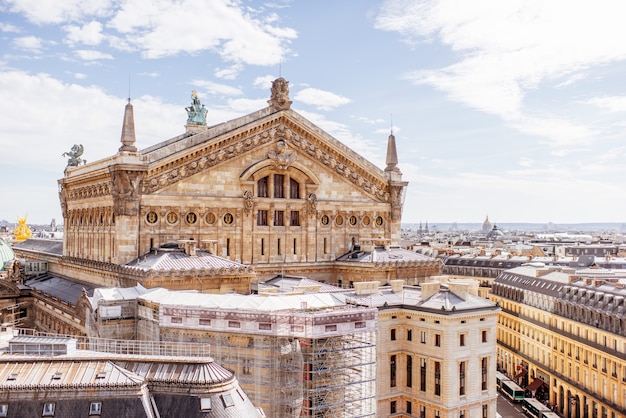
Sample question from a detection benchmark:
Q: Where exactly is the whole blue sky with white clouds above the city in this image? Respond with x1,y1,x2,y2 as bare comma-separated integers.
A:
0,0,626,229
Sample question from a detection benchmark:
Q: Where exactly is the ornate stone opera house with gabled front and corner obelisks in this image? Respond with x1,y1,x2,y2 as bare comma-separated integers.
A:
53,78,441,292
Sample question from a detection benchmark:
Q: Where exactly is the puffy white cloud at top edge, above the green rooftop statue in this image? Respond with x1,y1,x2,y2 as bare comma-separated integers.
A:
108,0,296,65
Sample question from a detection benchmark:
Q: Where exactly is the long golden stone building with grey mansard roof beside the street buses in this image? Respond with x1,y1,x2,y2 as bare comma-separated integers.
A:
491,263,626,418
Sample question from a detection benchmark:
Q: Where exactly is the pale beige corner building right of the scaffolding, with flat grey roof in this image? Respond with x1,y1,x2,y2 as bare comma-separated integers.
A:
346,280,500,418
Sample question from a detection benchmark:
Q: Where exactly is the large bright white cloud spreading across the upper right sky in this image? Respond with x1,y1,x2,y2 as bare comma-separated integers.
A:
376,0,626,147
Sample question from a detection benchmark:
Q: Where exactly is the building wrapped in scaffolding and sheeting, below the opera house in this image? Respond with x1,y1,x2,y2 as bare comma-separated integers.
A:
75,295,377,418
